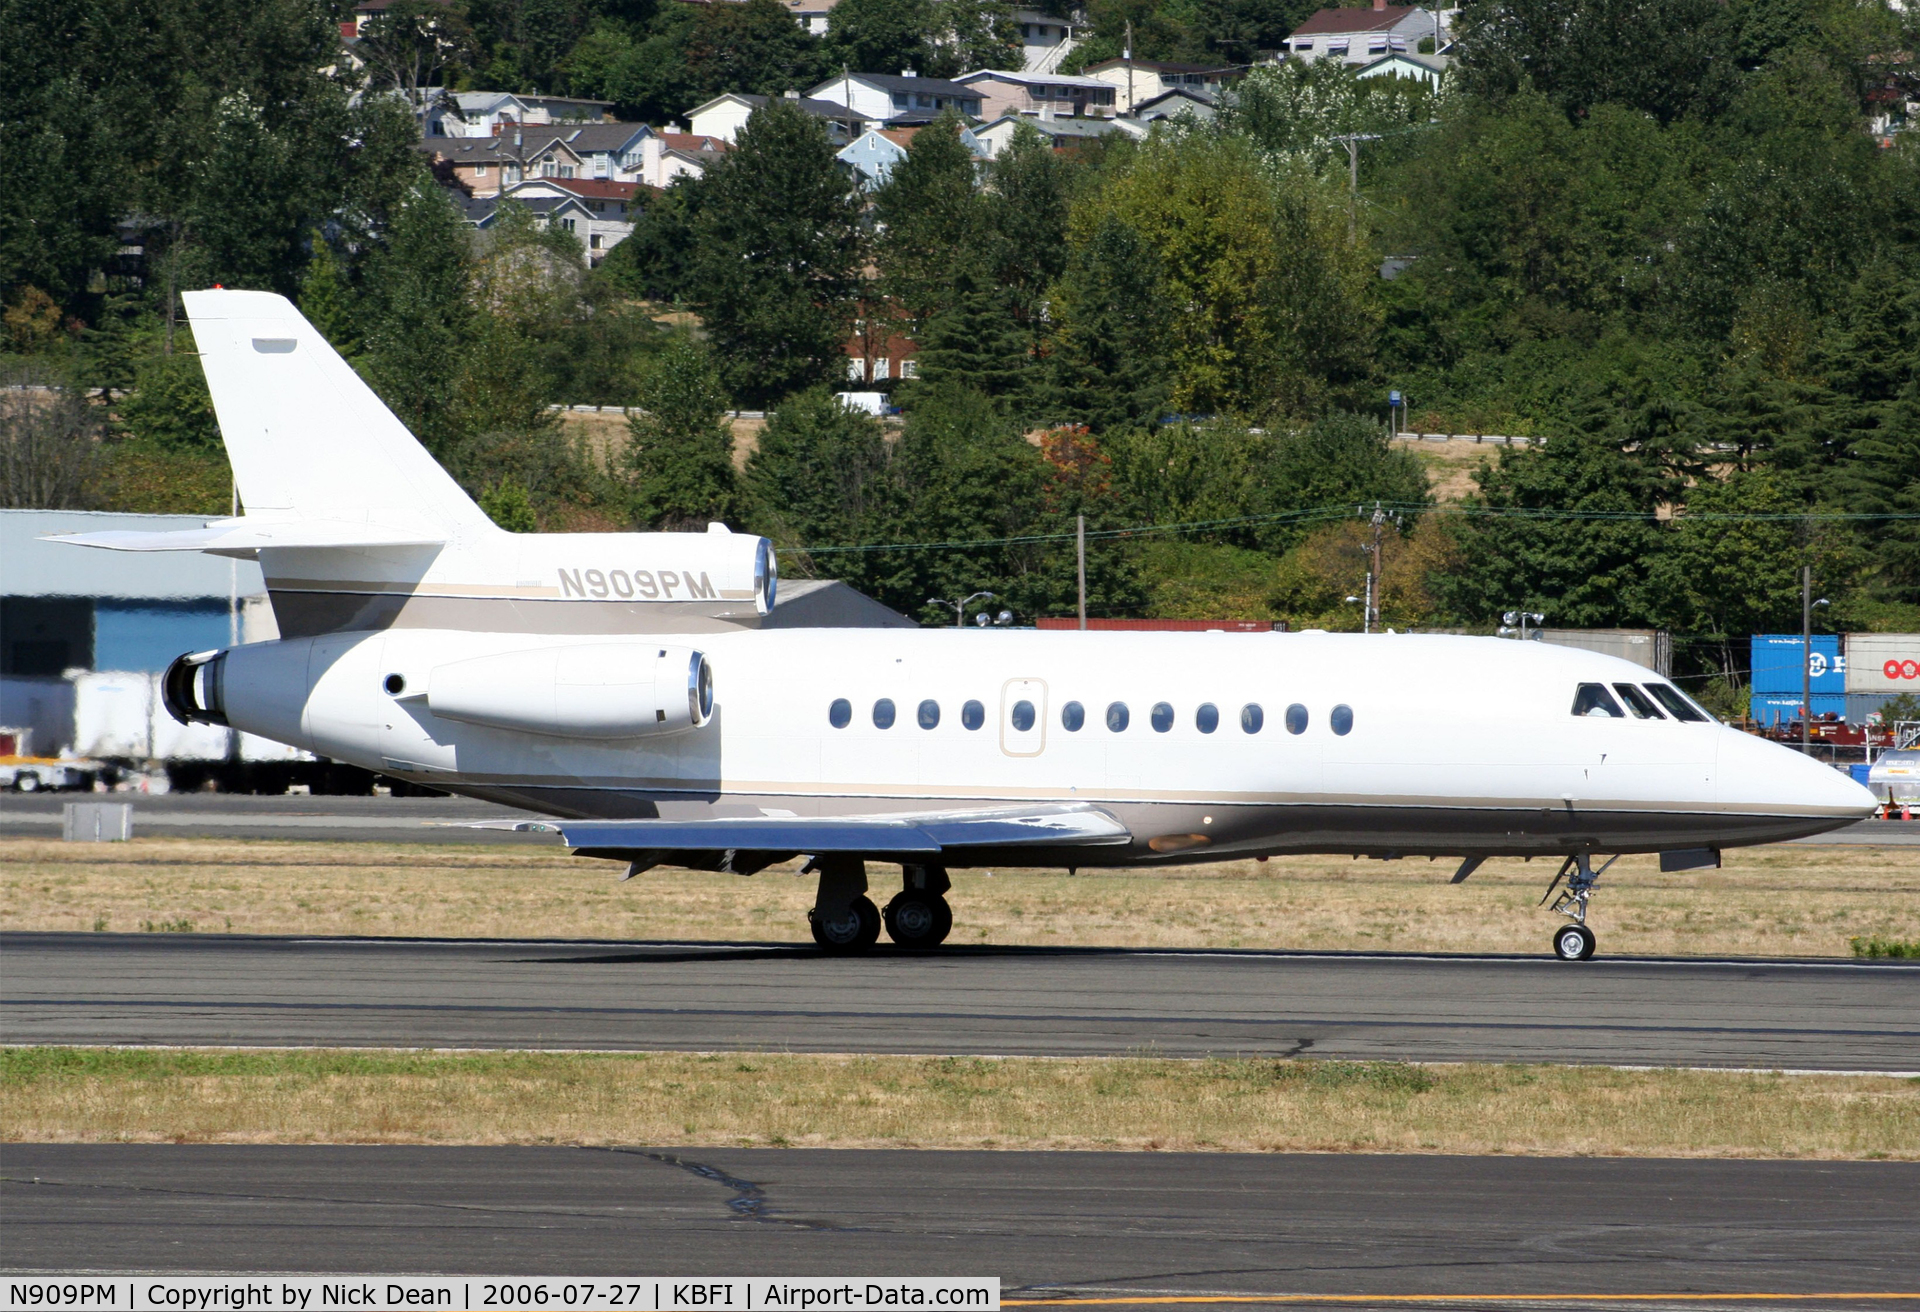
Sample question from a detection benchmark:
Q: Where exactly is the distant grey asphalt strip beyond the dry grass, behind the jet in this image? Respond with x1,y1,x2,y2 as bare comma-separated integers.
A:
0,793,1920,847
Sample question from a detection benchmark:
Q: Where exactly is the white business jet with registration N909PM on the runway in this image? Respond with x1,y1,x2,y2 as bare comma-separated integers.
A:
48,290,1874,959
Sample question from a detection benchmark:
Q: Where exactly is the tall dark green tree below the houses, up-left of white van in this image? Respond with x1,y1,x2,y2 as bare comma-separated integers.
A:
689,100,862,405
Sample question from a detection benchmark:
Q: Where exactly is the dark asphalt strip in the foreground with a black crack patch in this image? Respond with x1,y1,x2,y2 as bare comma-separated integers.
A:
0,1145,1920,1308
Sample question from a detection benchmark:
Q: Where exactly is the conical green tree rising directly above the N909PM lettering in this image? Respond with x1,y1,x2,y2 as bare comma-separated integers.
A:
628,334,739,530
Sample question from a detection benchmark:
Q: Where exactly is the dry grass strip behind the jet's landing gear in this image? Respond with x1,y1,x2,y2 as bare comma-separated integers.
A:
0,838,1920,957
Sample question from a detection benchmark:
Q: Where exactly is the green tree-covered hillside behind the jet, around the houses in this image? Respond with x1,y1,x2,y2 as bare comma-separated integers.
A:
0,0,1920,690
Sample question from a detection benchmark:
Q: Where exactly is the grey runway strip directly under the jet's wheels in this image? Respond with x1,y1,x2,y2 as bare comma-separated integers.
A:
0,934,1920,1070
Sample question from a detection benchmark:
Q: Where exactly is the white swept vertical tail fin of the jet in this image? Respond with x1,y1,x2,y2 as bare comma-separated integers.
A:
184,290,495,538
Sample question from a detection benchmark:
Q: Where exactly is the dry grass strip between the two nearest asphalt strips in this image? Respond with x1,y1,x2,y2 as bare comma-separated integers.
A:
0,1049,1920,1160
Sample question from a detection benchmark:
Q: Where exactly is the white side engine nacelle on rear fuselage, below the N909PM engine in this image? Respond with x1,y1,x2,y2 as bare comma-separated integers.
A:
424,642,714,738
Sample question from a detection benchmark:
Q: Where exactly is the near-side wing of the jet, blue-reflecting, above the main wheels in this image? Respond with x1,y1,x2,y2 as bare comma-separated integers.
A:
533,805,1133,870
